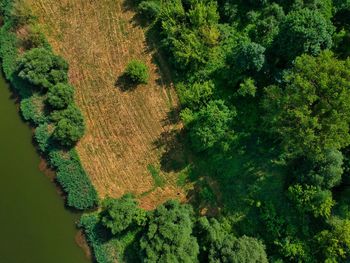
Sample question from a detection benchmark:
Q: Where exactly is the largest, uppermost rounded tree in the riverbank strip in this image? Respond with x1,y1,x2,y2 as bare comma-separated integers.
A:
17,48,68,89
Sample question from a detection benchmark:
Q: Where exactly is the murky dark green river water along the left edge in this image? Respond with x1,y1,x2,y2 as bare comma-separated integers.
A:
0,76,90,263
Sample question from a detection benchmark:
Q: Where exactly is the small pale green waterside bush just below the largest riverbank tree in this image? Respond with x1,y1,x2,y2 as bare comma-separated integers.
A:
20,94,47,125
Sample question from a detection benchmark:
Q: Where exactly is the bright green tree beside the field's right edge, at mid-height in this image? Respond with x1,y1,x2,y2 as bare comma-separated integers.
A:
190,100,236,152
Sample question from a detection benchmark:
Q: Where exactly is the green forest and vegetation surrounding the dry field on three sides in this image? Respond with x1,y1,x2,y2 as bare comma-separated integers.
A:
0,0,350,263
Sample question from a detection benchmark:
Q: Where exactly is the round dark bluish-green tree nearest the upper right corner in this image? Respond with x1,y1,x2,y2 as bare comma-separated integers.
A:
274,8,334,62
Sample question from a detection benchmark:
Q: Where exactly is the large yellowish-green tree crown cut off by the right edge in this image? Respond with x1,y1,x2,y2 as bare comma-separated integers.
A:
263,51,350,158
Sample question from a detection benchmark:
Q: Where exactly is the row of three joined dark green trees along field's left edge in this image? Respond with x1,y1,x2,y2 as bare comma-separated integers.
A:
17,48,85,147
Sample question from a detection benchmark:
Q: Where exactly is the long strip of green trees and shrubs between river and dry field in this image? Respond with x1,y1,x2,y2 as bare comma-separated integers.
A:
0,0,98,210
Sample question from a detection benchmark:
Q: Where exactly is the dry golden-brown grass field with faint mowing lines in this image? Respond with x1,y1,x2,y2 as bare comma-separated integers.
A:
27,0,189,209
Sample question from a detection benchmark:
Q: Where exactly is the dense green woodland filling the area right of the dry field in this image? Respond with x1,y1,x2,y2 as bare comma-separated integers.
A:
120,0,350,262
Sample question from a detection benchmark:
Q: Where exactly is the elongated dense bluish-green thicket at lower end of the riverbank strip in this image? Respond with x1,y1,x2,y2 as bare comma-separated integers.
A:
49,150,98,210
